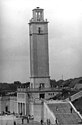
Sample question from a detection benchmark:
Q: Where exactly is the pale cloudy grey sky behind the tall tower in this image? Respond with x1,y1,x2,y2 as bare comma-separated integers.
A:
0,0,82,83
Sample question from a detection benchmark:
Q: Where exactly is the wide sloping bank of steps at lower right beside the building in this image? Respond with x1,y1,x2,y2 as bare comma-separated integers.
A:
48,102,81,125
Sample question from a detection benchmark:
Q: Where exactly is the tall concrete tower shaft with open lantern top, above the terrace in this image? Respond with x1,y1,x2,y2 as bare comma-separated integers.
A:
29,7,50,88
